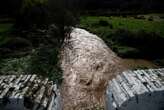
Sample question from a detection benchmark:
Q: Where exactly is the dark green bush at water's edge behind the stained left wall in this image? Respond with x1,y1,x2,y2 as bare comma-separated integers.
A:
28,46,62,84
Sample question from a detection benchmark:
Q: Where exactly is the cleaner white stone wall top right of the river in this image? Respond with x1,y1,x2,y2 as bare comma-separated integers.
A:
106,69,164,110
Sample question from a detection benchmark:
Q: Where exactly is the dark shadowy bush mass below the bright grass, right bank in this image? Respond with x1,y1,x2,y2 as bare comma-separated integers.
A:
111,29,164,59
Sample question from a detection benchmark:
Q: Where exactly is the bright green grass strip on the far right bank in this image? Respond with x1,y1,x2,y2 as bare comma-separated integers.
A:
80,16,164,36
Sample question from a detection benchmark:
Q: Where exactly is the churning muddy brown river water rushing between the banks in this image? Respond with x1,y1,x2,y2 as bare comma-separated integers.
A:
61,28,122,110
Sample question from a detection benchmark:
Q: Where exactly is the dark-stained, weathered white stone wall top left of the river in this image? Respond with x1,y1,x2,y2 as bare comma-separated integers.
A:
0,75,60,110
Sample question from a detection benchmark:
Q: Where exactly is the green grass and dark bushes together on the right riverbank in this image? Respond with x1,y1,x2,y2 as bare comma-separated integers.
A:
80,16,164,59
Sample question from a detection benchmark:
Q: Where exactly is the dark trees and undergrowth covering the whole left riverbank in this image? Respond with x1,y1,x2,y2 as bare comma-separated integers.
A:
0,0,76,84
